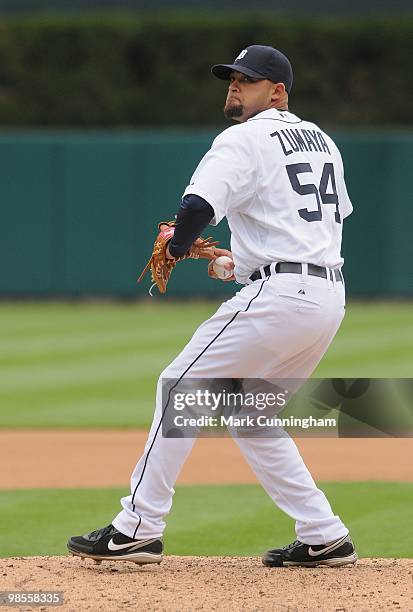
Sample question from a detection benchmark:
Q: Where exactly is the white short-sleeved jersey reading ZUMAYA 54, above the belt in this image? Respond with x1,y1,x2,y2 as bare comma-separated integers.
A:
184,109,353,284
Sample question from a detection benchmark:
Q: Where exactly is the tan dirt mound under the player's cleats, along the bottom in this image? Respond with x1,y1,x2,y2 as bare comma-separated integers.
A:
0,556,413,612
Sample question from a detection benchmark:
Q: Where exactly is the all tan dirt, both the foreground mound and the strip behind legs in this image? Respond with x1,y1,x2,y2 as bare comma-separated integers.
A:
0,431,413,612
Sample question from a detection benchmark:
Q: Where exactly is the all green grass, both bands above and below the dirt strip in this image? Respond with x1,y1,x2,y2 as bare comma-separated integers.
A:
0,299,413,557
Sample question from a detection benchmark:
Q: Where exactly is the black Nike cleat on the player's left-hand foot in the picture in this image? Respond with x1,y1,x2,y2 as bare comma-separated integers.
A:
67,525,163,565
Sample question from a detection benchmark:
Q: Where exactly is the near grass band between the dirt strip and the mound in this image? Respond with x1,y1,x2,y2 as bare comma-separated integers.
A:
0,483,413,557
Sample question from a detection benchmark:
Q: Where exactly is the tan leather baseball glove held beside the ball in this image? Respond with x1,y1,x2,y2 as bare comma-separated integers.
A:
138,221,218,293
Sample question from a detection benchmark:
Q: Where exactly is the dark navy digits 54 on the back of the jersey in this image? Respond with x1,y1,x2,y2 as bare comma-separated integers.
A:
285,162,341,223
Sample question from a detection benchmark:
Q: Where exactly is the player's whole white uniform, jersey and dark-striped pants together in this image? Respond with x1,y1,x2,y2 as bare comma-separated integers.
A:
112,110,352,545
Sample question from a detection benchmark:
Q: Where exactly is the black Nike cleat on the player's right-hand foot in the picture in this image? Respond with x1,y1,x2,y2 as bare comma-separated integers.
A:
262,534,357,567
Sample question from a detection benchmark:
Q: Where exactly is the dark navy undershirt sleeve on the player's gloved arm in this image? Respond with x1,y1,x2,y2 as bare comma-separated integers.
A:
169,193,215,257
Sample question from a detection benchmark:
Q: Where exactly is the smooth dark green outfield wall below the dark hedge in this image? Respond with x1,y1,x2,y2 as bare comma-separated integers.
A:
0,131,413,296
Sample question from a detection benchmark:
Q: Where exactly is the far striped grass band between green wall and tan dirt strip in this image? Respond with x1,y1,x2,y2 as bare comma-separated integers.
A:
0,299,413,428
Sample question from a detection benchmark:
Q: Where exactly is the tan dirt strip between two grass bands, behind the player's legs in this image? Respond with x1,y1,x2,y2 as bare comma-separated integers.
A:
0,430,413,489
